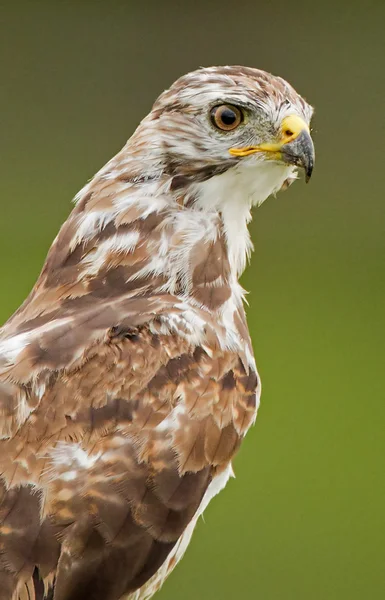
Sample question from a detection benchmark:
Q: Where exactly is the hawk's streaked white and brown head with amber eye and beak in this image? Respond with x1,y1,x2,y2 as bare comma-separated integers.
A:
134,67,314,203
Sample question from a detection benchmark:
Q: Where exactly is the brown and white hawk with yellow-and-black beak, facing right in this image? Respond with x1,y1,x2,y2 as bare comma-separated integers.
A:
0,66,314,600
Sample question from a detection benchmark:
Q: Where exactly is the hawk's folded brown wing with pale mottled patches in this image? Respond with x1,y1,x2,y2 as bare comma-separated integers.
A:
0,295,255,600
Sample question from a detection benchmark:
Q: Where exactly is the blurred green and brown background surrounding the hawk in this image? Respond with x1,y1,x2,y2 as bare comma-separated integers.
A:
0,0,385,600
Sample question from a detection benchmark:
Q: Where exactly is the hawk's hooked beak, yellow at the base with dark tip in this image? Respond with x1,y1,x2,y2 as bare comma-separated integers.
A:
229,115,315,183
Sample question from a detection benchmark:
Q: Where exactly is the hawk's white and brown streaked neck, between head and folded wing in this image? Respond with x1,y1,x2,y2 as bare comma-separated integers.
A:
7,154,294,338
